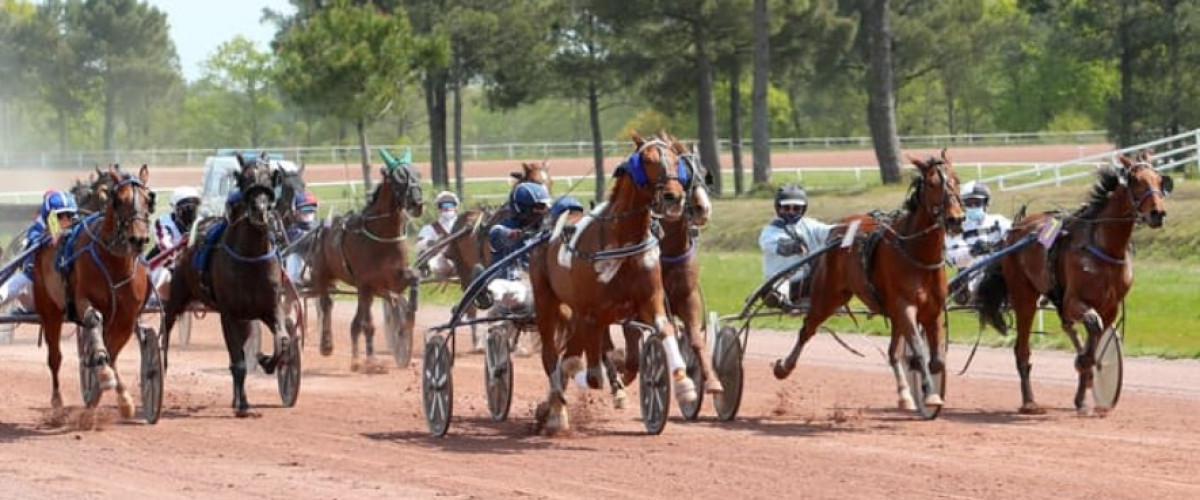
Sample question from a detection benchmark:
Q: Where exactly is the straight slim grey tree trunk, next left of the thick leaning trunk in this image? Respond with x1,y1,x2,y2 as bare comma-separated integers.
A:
750,0,770,185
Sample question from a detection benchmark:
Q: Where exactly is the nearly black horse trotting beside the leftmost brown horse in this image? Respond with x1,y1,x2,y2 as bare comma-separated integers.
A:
162,155,300,417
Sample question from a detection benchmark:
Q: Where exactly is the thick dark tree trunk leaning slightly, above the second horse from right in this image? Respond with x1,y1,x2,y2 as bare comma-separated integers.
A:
863,0,900,185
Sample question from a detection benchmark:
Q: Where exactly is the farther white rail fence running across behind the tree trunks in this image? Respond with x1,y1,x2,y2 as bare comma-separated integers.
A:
0,131,1108,169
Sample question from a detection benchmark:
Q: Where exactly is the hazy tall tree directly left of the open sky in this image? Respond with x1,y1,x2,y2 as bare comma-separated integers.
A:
79,0,180,151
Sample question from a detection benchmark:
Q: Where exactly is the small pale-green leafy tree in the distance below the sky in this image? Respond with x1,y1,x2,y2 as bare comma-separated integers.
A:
202,35,287,147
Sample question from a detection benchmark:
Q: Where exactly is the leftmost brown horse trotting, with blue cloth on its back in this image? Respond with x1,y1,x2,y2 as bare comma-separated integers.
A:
34,165,154,418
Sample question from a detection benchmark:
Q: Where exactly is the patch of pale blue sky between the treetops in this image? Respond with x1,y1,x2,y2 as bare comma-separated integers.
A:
146,0,294,82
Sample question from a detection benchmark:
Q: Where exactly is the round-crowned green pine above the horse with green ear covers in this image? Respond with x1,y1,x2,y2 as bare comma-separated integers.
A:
274,0,420,189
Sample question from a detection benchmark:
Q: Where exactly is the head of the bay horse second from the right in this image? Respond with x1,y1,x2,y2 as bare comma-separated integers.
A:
905,149,966,234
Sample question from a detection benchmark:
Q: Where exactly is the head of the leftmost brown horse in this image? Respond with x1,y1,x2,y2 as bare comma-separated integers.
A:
104,164,155,253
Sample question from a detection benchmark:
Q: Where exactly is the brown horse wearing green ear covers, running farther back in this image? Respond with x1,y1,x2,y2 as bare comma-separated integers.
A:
308,150,425,373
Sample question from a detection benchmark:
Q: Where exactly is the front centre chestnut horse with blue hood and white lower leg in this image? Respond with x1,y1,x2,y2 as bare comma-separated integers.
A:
529,132,696,432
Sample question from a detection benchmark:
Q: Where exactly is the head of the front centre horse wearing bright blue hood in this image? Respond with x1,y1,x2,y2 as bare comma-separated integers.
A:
624,132,690,221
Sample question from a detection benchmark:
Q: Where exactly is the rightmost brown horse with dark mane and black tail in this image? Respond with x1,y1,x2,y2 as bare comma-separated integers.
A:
977,153,1174,414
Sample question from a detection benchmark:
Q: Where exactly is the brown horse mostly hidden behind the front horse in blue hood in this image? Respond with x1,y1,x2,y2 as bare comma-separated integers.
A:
613,139,724,408
